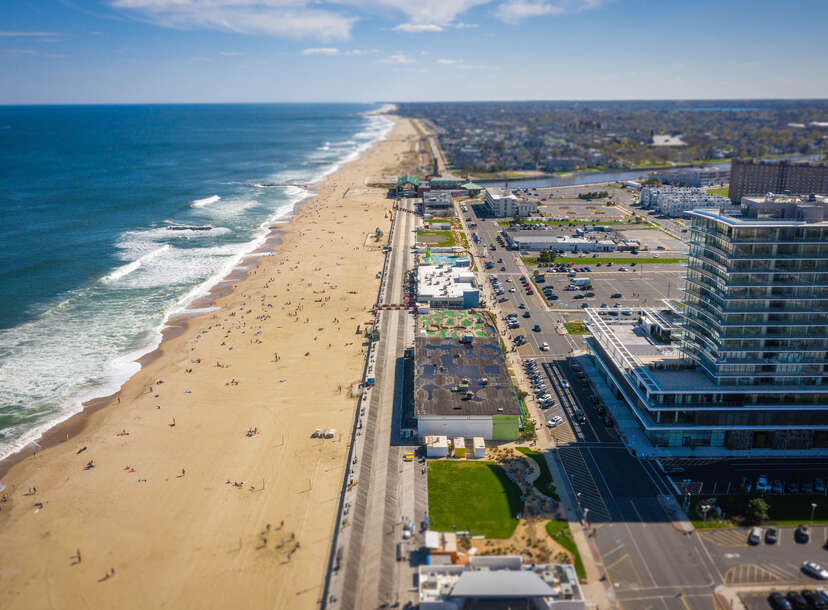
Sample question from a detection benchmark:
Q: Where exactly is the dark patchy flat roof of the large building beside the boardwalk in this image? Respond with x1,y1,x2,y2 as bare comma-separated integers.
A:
414,335,521,417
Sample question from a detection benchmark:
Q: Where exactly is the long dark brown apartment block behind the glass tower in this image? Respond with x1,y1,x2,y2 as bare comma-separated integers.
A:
728,159,828,203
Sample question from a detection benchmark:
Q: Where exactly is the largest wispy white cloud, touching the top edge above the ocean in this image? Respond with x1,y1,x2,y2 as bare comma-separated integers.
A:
110,0,356,40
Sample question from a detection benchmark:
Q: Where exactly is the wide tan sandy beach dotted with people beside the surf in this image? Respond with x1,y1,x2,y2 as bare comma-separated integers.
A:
0,120,415,609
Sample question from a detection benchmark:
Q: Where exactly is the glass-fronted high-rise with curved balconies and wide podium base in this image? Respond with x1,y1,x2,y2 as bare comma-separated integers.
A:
588,196,828,449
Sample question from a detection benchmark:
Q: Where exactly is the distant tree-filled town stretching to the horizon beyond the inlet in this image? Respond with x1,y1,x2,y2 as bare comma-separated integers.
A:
398,100,828,179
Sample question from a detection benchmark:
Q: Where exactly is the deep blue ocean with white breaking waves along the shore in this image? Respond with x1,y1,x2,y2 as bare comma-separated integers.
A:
0,104,391,458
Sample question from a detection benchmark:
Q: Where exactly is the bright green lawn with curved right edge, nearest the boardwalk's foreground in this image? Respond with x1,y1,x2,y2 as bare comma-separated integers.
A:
428,460,523,538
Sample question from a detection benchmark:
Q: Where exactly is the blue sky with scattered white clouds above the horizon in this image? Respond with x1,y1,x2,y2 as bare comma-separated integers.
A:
0,0,828,104
